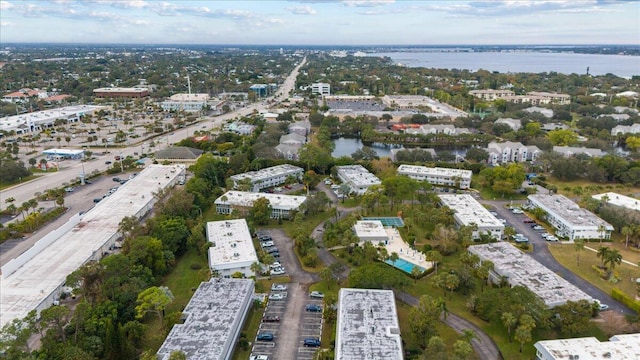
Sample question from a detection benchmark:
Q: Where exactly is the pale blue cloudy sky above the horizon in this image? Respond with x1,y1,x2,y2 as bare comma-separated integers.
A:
0,0,640,46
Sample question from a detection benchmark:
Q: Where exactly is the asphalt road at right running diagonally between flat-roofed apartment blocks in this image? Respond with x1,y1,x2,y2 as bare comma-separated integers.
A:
480,200,635,315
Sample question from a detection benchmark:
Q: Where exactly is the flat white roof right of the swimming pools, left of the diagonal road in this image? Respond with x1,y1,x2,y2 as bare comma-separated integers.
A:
438,194,504,229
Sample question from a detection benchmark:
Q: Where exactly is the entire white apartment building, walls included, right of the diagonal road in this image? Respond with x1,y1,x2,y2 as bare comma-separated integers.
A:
528,194,614,241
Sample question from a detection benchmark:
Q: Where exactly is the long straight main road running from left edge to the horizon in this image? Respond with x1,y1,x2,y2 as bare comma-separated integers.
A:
0,57,306,214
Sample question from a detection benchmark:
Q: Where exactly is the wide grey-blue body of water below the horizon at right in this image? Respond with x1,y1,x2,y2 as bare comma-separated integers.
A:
367,50,640,78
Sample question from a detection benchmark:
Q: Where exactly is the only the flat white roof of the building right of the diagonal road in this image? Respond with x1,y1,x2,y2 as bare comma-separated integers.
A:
528,194,613,230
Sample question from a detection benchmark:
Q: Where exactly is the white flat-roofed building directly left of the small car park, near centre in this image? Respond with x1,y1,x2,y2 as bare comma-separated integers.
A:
207,219,258,277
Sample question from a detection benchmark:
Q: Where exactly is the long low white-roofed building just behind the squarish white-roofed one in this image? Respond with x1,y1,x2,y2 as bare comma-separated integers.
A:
214,191,307,219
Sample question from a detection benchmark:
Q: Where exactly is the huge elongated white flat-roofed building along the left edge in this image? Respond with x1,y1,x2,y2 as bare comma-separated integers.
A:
0,165,184,328
